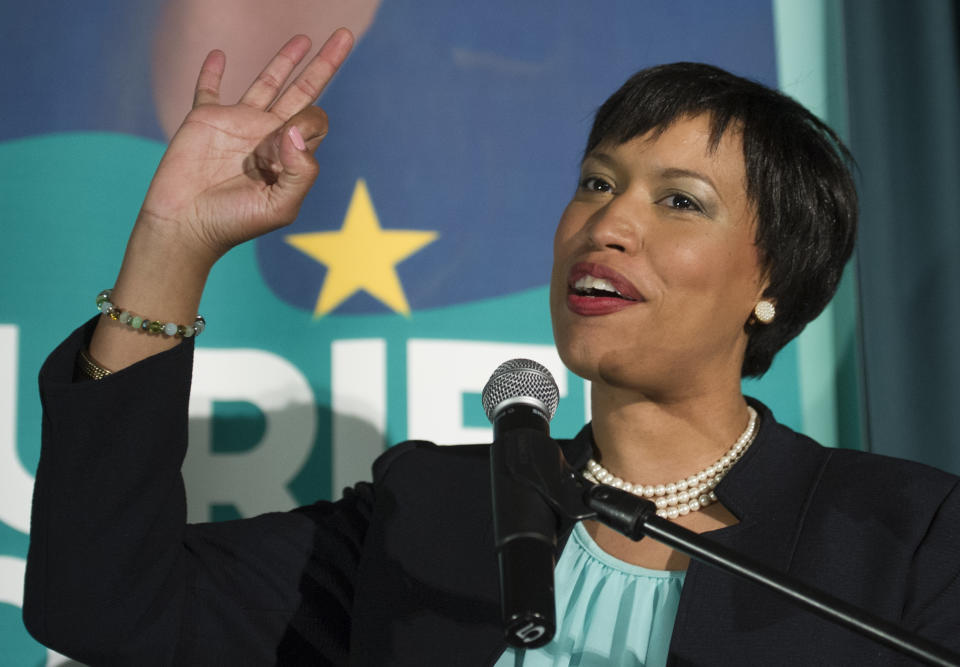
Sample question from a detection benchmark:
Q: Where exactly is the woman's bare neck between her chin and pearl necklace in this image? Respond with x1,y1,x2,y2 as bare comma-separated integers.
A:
591,383,749,484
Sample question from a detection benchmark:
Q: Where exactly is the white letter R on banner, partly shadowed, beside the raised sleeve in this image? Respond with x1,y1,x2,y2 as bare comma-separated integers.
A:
183,349,317,521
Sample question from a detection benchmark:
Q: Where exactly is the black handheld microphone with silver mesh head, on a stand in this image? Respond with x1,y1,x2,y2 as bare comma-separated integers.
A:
482,359,560,648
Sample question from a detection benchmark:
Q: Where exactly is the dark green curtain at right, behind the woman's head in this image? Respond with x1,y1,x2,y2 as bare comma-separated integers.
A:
844,0,960,473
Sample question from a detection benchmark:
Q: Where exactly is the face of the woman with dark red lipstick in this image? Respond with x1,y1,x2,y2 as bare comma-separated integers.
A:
550,115,766,397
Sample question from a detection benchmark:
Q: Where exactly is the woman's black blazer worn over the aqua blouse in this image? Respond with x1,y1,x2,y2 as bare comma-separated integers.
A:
24,324,960,665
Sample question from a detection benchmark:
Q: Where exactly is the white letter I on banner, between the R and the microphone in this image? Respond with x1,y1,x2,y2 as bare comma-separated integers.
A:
330,338,387,498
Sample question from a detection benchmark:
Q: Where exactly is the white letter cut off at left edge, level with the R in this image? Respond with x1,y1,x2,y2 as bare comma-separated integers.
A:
0,324,33,533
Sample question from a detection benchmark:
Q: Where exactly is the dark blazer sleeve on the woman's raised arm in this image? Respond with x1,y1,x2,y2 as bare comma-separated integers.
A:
23,321,373,665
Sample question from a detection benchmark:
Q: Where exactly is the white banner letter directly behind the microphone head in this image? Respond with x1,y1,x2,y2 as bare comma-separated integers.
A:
407,338,567,445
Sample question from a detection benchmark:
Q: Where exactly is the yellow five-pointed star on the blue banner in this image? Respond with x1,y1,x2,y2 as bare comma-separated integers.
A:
284,178,437,317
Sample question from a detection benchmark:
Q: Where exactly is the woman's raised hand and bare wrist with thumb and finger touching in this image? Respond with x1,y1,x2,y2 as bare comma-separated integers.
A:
90,28,353,371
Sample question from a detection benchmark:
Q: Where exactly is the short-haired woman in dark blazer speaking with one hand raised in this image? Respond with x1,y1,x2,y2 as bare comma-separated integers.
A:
24,30,960,665
